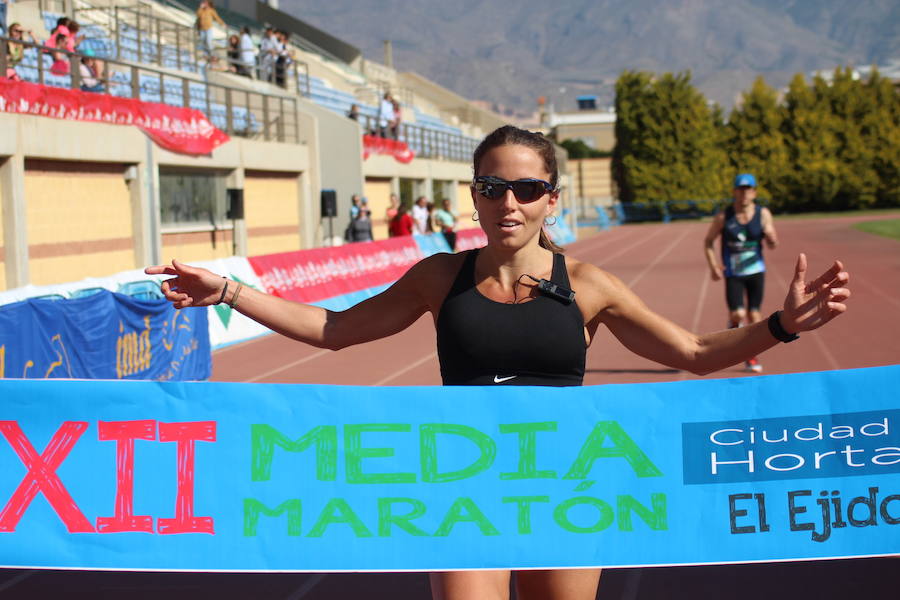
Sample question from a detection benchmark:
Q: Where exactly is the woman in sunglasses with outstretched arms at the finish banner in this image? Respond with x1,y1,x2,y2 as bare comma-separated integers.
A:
146,126,850,600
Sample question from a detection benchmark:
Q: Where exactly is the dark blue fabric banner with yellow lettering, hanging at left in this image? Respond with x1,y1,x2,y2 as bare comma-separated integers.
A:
0,290,212,381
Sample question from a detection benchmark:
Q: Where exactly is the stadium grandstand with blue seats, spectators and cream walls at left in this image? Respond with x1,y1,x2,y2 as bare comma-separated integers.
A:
0,0,565,293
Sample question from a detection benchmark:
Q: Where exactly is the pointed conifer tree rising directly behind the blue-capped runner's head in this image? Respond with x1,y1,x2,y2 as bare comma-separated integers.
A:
723,77,788,210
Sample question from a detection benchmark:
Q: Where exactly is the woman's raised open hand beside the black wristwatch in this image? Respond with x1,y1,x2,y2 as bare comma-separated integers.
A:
781,254,850,333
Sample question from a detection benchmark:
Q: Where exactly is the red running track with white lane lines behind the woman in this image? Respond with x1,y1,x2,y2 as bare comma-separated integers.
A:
212,217,900,385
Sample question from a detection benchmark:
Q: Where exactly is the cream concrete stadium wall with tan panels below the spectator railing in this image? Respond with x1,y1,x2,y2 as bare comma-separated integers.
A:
0,113,322,289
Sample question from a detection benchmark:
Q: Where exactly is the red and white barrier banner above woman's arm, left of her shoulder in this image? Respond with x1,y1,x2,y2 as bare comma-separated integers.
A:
247,236,424,302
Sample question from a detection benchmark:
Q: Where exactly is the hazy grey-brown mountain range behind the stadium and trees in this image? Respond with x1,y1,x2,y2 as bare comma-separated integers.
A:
281,0,900,114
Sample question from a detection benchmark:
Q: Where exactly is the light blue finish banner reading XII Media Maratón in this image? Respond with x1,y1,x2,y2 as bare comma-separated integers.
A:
0,366,900,571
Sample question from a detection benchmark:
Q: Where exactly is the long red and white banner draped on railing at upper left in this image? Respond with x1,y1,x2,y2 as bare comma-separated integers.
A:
0,79,229,154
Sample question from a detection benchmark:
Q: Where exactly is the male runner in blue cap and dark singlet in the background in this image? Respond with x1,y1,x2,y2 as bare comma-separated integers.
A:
704,173,778,373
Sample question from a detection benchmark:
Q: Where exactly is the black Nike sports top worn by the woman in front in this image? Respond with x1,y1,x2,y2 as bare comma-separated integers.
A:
437,250,587,386
